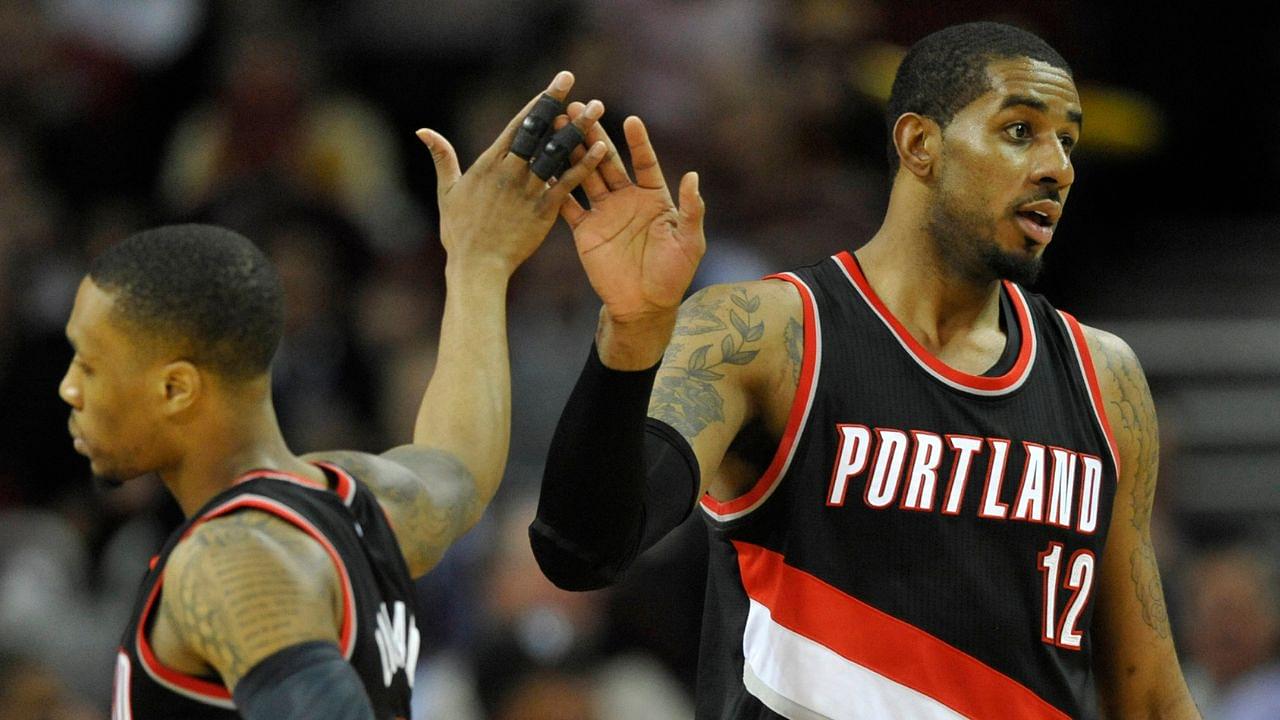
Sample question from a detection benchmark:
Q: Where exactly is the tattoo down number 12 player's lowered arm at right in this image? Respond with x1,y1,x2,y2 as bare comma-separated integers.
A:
1093,334,1170,638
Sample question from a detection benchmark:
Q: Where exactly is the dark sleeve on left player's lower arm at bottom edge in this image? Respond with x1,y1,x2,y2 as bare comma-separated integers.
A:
234,641,374,720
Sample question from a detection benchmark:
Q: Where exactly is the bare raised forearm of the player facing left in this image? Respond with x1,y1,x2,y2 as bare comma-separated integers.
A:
413,259,511,509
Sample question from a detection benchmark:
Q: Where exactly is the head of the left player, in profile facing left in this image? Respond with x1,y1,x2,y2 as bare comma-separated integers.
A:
59,225,283,480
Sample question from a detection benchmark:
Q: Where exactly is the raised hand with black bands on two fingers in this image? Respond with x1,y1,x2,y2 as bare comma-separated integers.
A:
417,72,605,275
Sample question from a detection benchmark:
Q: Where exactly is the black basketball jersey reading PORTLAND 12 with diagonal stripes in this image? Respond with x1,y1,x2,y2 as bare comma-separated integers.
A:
698,252,1117,720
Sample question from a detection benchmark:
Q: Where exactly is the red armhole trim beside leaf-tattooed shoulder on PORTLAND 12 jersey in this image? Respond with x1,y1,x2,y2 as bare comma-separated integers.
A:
701,273,820,520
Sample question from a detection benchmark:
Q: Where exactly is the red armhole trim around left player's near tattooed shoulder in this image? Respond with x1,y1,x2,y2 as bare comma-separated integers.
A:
134,495,357,710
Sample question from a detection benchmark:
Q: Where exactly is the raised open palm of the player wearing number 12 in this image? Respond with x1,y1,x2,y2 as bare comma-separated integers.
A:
561,112,707,333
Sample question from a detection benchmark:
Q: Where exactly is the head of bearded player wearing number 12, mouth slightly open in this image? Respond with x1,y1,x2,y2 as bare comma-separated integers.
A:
886,22,1083,282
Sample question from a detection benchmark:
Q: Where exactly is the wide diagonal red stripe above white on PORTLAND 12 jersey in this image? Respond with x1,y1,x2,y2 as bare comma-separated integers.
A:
733,541,1068,720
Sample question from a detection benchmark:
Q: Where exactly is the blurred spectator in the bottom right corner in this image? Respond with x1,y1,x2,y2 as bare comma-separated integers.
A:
1184,547,1280,720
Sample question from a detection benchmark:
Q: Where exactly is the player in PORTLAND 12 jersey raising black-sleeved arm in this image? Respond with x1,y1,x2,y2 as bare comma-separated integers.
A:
530,23,1198,720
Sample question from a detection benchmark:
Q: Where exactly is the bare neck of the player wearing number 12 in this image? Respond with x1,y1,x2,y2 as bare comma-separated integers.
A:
856,186,1001,351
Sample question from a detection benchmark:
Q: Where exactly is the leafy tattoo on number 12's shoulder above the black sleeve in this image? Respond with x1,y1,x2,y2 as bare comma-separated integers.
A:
649,287,764,438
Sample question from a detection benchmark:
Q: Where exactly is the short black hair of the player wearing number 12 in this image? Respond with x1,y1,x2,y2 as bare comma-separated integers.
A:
884,22,1071,173
